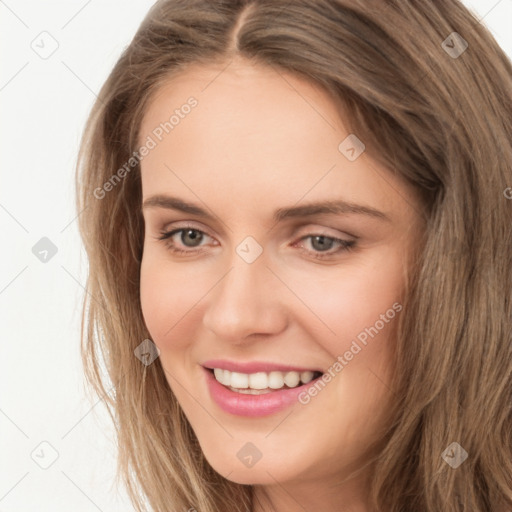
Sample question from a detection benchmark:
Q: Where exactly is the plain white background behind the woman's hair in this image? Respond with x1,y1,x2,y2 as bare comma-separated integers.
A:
0,0,512,512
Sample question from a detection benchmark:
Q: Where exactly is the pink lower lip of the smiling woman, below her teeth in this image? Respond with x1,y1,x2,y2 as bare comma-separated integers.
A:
203,368,322,417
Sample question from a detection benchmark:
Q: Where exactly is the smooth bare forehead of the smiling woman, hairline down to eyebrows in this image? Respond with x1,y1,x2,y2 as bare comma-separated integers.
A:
140,61,420,224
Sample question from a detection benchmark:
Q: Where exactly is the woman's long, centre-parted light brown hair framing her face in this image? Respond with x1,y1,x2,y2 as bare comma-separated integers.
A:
77,0,512,512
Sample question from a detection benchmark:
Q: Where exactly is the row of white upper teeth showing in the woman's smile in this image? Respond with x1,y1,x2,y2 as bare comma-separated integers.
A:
213,368,314,388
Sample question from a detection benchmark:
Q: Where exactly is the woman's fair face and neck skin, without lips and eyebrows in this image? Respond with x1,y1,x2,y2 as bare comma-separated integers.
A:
140,59,423,512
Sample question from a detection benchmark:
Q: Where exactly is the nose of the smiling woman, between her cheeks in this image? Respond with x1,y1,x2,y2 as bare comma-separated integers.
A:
203,257,287,343
